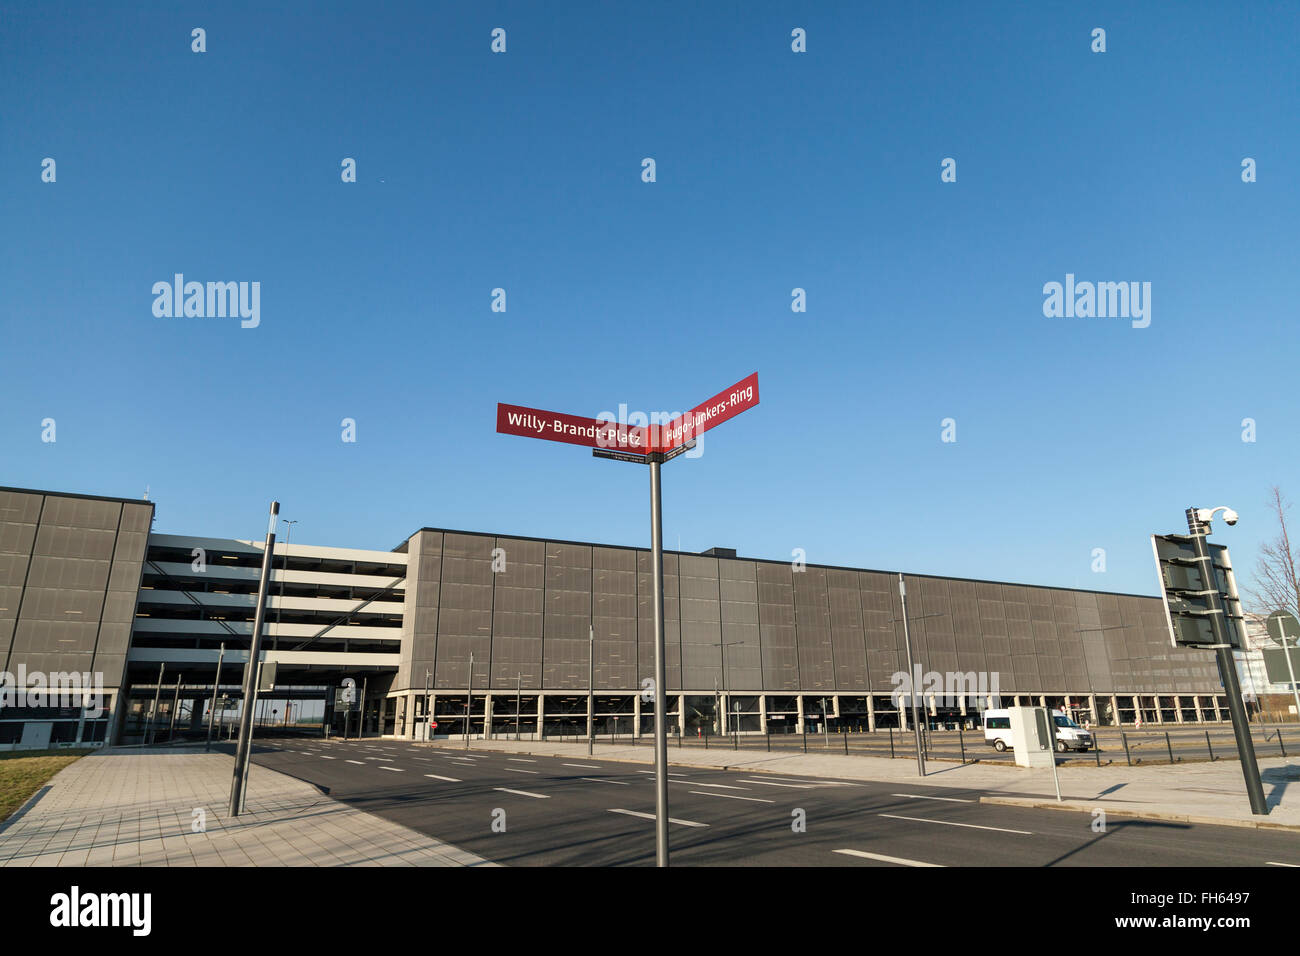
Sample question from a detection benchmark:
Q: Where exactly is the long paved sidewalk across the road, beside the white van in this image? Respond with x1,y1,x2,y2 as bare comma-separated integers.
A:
430,740,1300,830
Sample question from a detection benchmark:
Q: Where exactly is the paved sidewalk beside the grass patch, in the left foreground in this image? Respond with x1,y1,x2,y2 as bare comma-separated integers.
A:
0,748,494,866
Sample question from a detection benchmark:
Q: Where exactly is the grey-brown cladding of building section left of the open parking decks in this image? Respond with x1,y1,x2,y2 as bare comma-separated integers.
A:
0,490,153,687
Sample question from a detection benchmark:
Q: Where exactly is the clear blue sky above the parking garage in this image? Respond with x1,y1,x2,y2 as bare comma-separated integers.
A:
0,3,1300,593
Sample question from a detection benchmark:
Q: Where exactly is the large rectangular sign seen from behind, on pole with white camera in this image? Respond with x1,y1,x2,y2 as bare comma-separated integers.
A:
1151,535,1247,648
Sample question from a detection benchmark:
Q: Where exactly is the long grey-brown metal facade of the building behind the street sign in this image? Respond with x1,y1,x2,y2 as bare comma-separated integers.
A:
391,528,1222,695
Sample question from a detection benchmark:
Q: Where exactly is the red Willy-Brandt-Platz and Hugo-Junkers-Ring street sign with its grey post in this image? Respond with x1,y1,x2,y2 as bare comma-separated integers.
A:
497,372,758,866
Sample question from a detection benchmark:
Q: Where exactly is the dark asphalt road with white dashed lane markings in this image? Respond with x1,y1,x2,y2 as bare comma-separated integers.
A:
236,739,1300,866
